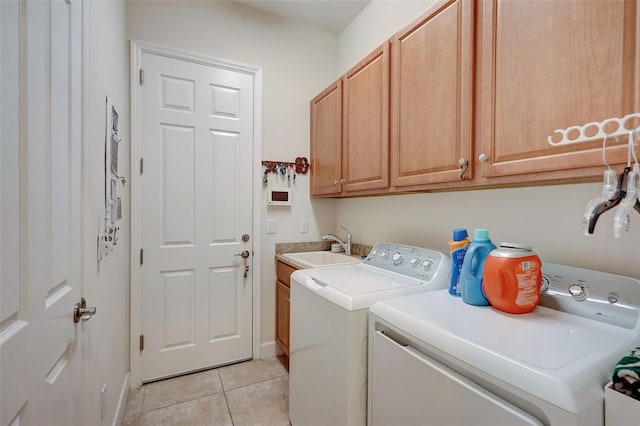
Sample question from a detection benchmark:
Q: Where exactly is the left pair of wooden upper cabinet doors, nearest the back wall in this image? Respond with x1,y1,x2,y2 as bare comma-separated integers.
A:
311,42,390,195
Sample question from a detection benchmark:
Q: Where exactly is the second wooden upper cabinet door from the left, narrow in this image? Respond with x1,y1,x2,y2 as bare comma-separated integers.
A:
342,42,390,192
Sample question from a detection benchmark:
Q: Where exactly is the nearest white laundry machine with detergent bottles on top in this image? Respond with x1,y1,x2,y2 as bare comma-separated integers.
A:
368,264,640,426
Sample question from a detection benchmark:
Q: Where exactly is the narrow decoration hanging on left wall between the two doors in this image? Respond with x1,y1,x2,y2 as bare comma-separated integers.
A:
98,97,126,262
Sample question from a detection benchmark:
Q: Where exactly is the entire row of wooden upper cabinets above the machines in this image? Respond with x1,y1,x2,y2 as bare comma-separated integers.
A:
311,0,640,196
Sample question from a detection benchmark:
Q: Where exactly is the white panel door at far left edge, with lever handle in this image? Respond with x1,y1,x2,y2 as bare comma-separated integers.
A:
0,0,84,425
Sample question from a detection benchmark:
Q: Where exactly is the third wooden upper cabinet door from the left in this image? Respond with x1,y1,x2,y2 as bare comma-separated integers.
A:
391,0,473,187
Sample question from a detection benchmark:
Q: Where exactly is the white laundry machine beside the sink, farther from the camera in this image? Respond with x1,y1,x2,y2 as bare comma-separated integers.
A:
289,243,450,426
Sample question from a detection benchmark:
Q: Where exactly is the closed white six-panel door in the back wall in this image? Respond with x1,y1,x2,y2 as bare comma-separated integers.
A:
139,53,254,381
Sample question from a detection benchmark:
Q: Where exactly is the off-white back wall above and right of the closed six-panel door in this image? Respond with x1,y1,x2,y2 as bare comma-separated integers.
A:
127,1,337,356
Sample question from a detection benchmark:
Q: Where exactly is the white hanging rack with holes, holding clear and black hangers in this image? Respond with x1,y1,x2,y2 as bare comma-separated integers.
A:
548,113,640,238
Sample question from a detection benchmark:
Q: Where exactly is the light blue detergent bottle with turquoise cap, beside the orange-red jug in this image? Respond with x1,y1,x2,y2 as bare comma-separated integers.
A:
459,229,496,306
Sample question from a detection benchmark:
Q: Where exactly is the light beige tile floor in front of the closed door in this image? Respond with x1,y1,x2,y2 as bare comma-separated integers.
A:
122,358,289,426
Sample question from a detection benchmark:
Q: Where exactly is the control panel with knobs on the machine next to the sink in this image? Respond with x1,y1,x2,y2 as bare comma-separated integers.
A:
362,243,451,281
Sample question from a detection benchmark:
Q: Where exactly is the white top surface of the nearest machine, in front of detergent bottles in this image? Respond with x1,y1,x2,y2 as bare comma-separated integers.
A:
371,291,639,413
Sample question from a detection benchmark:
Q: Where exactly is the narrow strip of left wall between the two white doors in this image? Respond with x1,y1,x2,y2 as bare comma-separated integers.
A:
82,1,130,425
